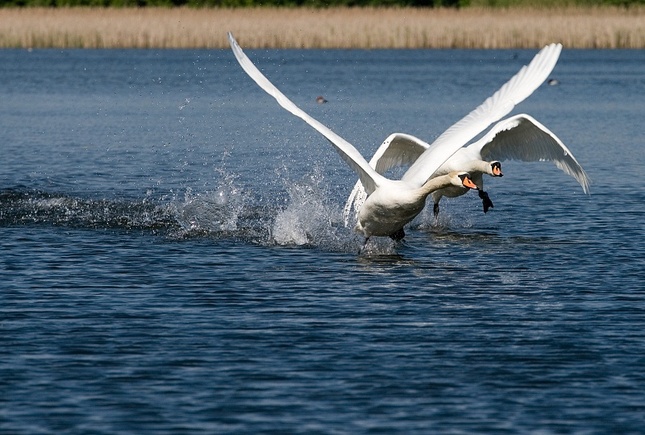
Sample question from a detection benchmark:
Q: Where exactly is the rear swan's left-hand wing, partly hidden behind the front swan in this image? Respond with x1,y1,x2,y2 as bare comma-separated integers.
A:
343,133,430,226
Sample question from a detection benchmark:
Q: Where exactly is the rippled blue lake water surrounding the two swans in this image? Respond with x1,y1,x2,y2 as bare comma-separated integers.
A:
0,49,645,434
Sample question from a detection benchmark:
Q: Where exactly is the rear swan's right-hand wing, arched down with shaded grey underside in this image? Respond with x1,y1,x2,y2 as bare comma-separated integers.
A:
476,114,589,193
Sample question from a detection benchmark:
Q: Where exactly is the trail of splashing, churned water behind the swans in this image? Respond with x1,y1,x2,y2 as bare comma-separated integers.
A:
0,168,438,257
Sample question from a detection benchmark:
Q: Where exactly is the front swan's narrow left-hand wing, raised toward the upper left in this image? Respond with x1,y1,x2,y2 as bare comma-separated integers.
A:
228,32,385,193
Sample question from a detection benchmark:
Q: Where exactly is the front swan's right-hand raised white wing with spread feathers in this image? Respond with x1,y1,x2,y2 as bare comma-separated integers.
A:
403,44,562,186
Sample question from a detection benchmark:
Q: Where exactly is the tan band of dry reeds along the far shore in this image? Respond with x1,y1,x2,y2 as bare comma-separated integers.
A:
0,7,645,49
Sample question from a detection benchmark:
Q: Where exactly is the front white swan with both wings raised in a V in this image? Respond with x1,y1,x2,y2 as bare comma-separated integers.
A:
228,32,562,243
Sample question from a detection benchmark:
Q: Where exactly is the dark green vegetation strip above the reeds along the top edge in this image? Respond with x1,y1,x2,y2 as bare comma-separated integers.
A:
0,0,645,8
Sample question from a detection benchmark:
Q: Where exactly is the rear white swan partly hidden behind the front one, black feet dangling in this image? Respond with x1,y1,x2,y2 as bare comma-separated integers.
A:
343,113,589,225
